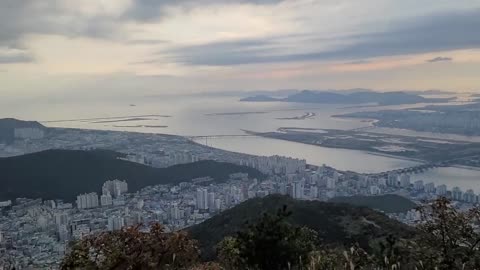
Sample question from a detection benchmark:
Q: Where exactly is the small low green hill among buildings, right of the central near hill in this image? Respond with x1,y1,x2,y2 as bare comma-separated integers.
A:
330,194,417,213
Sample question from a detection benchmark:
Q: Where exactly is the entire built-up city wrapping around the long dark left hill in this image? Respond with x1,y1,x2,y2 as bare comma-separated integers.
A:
0,124,480,269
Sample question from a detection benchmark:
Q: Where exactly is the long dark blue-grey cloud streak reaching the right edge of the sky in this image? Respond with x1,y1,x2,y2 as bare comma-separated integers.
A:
165,9,480,66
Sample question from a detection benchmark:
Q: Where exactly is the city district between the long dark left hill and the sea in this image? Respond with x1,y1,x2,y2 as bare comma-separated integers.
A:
0,128,306,173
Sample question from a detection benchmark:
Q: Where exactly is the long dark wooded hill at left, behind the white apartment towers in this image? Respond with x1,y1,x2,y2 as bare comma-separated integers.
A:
0,150,263,202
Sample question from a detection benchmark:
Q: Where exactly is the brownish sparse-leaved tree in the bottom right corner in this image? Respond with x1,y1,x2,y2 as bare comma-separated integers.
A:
413,197,480,269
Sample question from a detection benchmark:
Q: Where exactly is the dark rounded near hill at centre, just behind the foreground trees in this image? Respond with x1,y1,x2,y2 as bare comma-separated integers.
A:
187,195,413,258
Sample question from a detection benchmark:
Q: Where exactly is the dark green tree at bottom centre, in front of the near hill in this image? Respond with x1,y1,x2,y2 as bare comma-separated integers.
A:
218,207,317,270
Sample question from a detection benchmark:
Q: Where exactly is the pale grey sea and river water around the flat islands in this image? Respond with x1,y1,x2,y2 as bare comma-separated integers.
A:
0,95,480,193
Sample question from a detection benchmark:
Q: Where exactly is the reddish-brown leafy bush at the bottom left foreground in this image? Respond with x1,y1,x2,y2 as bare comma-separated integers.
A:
61,224,200,270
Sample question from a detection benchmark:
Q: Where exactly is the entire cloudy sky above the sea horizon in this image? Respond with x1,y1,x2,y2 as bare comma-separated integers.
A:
0,0,480,97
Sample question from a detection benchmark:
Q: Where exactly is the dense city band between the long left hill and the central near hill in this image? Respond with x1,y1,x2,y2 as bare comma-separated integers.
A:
0,156,456,269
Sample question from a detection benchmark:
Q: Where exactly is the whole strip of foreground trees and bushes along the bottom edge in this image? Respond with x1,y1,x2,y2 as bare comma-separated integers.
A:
62,198,480,270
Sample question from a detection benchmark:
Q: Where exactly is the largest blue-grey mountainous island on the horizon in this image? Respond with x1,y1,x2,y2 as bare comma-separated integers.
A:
240,90,454,105
